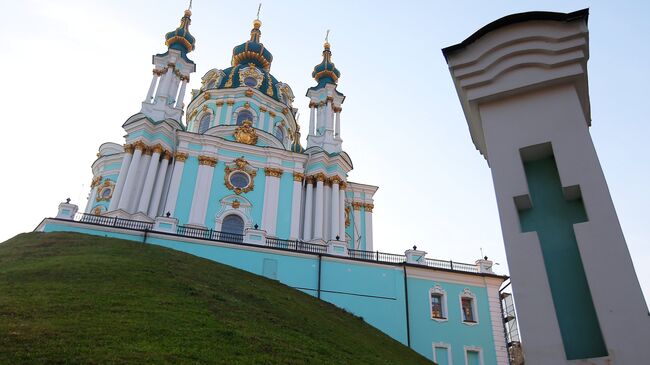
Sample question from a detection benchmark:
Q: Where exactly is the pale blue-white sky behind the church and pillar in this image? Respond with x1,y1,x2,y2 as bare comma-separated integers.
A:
0,0,650,298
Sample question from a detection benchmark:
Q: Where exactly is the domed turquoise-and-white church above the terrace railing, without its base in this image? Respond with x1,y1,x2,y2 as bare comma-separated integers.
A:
86,10,377,251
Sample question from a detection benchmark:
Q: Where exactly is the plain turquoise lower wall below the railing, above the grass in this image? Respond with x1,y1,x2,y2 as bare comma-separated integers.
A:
43,221,503,365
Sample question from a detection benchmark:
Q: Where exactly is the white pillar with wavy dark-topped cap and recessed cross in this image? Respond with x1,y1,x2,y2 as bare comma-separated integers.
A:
443,10,650,365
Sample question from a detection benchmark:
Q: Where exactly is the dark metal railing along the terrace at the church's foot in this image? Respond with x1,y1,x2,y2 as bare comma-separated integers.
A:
67,213,479,273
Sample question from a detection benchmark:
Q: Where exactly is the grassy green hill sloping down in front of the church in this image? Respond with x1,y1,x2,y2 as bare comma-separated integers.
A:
0,233,431,364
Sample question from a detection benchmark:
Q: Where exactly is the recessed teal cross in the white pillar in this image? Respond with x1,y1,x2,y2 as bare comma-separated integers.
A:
519,156,607,360
